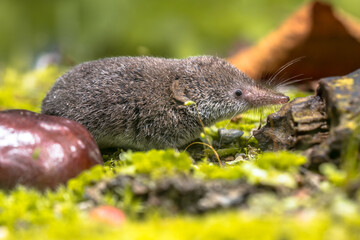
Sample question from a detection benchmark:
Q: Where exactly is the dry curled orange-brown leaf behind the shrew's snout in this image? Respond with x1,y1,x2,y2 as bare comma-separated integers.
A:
228,1,360,88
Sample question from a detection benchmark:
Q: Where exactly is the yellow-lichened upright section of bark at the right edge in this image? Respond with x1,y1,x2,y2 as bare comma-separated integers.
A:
309,69,360,165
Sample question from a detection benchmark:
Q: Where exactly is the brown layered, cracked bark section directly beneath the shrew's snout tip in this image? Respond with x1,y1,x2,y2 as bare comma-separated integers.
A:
254,96,328,151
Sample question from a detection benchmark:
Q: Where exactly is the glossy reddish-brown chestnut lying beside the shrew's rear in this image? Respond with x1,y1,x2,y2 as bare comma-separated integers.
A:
0,110,103,189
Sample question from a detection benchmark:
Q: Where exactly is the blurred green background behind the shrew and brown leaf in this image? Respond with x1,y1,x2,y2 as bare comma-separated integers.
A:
0,0,360,69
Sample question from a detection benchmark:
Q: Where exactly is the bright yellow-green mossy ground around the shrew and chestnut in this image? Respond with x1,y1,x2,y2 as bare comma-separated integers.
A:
0,68,360,240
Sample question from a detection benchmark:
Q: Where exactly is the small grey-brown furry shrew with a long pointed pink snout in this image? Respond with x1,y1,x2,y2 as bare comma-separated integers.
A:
42,56,288,150
